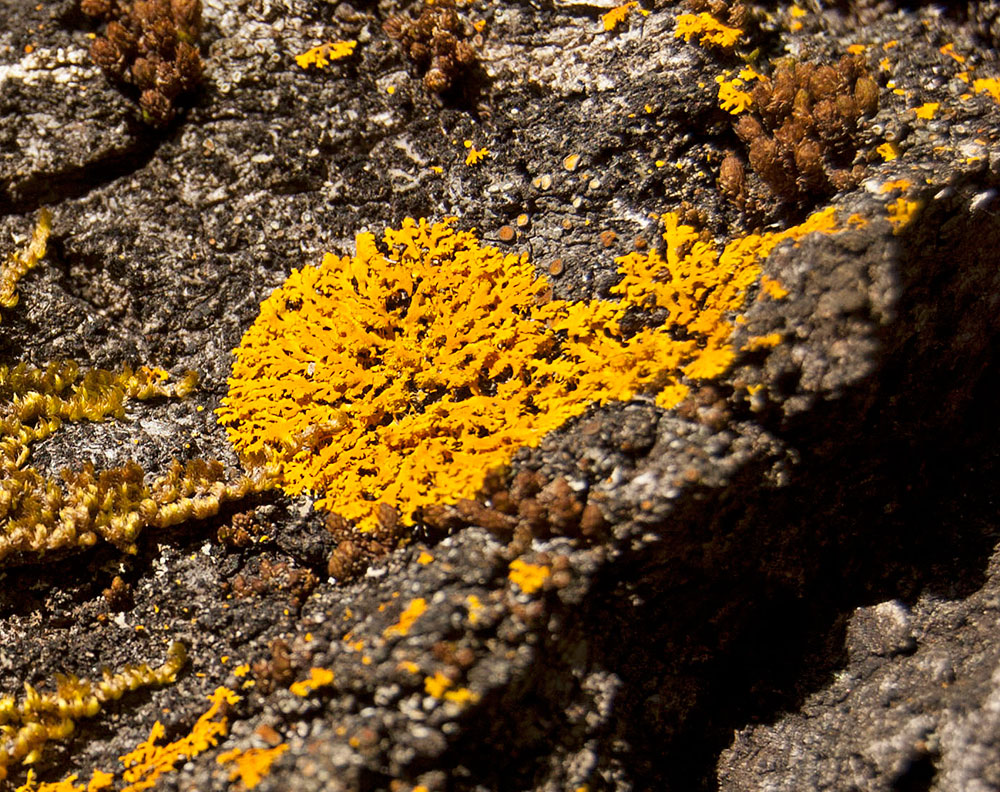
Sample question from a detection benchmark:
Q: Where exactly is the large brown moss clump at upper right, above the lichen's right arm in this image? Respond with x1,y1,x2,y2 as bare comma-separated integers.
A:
719,55,878,210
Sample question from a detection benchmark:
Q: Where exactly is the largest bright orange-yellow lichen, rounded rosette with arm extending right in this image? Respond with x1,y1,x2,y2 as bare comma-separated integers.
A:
218,209,837,530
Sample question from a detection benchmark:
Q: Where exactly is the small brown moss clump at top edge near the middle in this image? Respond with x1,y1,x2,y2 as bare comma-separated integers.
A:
382,0,479,93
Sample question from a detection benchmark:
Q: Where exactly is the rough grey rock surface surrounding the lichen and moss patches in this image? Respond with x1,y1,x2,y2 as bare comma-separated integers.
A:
0,0,1000,792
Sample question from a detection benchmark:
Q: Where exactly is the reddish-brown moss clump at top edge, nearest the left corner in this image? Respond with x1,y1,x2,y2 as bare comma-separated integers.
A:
80,0,202,126
